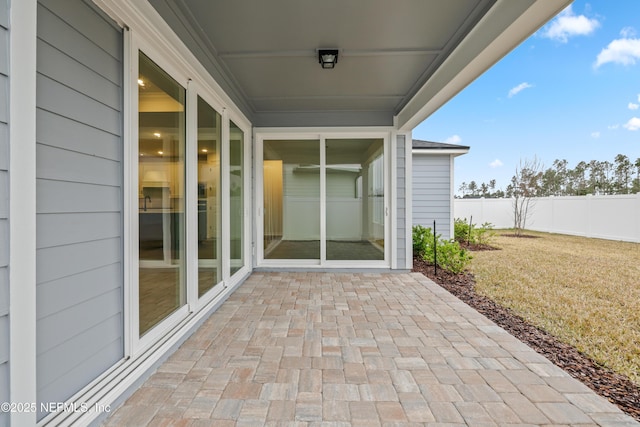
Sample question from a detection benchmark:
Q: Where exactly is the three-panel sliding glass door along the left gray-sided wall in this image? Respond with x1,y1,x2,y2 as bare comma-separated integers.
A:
130,46,248,342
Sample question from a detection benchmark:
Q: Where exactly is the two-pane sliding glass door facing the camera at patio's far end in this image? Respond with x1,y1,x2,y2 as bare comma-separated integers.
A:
261,138,386,266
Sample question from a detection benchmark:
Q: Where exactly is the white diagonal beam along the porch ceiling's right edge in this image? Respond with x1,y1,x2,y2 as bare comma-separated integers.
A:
397,0,573,130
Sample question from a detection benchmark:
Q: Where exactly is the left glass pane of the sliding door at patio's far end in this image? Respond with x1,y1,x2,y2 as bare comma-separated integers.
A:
263,140,320,260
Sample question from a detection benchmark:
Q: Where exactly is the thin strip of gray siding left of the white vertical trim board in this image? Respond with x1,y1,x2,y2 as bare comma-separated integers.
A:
0,0,11,427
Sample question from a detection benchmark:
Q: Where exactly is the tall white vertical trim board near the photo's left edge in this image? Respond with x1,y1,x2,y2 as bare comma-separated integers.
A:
9,0,37,427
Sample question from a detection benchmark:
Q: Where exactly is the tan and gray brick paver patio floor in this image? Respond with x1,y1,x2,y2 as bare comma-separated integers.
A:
105,273,640,426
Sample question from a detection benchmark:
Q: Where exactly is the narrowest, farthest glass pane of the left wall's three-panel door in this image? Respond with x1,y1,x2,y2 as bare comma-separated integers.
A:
229,122,245,275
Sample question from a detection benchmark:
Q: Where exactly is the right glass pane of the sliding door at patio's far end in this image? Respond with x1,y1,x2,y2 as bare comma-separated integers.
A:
325,139,385,260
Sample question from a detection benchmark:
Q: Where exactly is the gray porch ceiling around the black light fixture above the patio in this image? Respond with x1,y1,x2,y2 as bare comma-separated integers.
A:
150,0,570,130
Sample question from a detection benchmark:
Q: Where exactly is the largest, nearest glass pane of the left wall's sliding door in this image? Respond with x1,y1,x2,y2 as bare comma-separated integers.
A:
138,53,186,336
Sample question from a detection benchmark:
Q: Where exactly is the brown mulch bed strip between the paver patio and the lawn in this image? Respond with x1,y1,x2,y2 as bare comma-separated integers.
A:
413,257,640,421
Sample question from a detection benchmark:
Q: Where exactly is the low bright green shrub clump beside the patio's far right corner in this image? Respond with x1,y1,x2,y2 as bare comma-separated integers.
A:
413,225,471,274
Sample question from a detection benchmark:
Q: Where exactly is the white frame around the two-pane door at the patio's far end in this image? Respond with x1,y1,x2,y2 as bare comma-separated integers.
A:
254,127,396,269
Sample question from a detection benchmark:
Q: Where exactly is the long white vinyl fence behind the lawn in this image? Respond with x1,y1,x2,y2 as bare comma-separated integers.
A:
453,193,640,242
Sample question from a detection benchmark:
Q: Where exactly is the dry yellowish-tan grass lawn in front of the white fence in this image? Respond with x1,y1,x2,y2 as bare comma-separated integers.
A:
471,232,640,384
